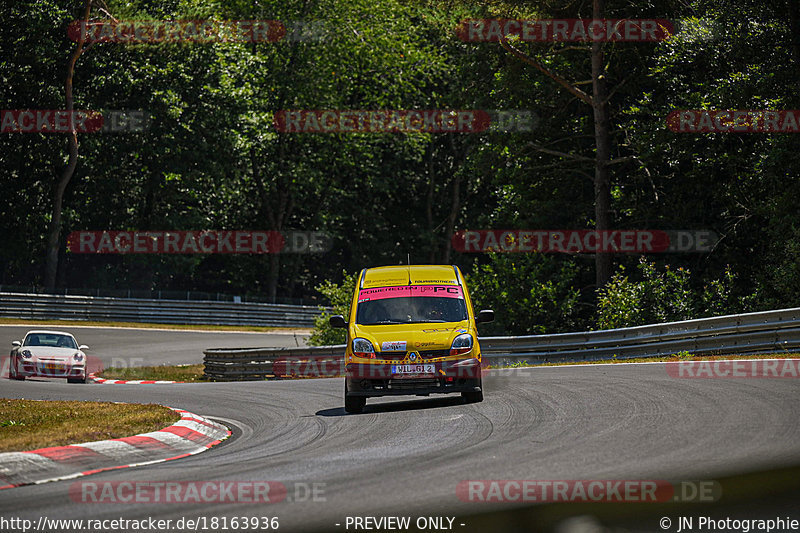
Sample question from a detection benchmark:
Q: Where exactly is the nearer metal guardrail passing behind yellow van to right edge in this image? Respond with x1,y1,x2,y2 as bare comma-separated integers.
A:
203,308,800,381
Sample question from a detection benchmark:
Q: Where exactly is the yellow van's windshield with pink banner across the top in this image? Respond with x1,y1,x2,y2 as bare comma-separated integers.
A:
356,285,467,325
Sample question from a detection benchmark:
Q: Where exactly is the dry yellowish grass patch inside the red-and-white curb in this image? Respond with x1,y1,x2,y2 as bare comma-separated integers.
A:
0,399,180,452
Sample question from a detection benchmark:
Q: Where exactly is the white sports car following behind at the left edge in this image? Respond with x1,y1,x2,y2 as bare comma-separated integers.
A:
8,330,89,383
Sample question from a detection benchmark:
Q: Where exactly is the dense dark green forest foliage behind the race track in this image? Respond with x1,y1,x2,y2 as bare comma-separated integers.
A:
0,0,800,332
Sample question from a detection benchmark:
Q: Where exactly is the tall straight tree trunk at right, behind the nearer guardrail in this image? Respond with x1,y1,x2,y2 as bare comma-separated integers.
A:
592,0,613,289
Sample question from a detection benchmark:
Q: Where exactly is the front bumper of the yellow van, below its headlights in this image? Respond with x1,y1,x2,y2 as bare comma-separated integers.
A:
345,358,481,396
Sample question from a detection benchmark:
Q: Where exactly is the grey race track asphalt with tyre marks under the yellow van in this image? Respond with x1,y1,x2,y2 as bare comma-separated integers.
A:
0,330,800,531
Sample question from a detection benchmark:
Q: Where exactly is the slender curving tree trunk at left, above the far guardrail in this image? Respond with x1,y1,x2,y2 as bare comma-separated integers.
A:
44,0,92,290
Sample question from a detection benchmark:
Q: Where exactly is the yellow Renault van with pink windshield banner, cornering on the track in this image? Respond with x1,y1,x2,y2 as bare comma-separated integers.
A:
330,265,494,413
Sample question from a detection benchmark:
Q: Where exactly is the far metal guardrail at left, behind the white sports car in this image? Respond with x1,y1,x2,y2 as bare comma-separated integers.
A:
0,292,320,328
